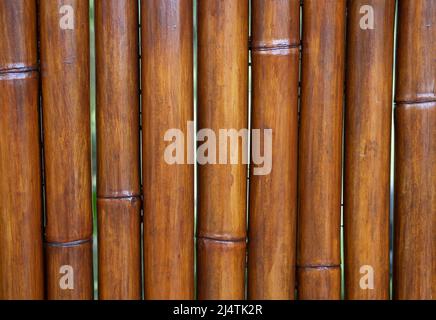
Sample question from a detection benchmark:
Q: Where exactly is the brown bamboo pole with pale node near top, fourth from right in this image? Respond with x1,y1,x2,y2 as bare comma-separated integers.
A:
248,0,300,300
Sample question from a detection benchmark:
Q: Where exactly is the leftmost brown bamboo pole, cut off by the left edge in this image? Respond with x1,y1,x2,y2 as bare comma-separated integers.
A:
0,0,44,300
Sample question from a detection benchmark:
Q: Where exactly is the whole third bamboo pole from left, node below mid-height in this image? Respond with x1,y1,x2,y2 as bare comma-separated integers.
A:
95,0,142,300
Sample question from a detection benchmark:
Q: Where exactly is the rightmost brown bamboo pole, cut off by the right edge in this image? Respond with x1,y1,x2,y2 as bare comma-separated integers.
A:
394,0,436,300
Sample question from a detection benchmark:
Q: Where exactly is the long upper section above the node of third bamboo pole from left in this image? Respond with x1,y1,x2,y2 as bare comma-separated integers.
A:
95,0,140,198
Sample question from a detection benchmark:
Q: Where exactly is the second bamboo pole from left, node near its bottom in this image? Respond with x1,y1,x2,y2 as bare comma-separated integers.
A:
39,0,93,299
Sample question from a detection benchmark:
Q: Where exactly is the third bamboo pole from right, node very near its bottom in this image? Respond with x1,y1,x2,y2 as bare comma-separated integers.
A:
297,0,345,299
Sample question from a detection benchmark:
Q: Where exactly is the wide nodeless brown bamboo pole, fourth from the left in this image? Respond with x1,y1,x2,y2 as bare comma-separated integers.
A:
141,0,194,299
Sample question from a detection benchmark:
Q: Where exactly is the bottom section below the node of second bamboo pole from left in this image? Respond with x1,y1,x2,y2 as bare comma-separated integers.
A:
45,241,94,300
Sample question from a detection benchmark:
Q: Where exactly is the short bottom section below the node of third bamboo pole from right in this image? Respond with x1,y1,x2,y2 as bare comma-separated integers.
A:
298,267,341,300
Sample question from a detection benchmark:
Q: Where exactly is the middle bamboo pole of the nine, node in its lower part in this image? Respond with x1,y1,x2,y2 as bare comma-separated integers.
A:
197,0,248,300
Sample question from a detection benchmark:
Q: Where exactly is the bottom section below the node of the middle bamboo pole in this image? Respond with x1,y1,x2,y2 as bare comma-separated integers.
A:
197,238,246,300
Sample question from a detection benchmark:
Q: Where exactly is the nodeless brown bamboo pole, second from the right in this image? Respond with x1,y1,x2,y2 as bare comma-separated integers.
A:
344,0,395,300
